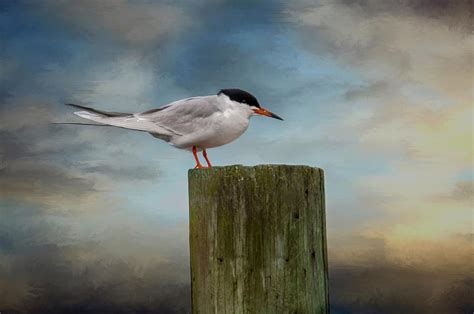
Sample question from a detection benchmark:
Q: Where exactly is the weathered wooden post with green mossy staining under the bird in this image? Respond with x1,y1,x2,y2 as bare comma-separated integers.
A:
188,165,329,314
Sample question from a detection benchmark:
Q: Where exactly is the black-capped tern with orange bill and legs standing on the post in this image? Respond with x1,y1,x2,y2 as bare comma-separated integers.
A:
67,88,283,168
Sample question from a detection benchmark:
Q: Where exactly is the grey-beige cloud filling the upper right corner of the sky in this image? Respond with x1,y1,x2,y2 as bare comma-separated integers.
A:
288,1,473,100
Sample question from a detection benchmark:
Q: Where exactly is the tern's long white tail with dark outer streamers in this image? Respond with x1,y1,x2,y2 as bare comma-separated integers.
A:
63,104,156,132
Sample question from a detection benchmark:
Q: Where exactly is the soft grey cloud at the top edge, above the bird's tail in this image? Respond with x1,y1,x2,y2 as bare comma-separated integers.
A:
33,0,194,50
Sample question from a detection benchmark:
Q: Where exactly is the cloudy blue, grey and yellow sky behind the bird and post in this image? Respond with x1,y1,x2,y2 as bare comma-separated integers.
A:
0,0,474,313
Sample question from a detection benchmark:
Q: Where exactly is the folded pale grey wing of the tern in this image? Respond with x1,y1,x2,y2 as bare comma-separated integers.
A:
137,95,221,135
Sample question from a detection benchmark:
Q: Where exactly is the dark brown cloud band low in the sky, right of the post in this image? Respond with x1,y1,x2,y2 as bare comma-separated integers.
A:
329,263,474,314
